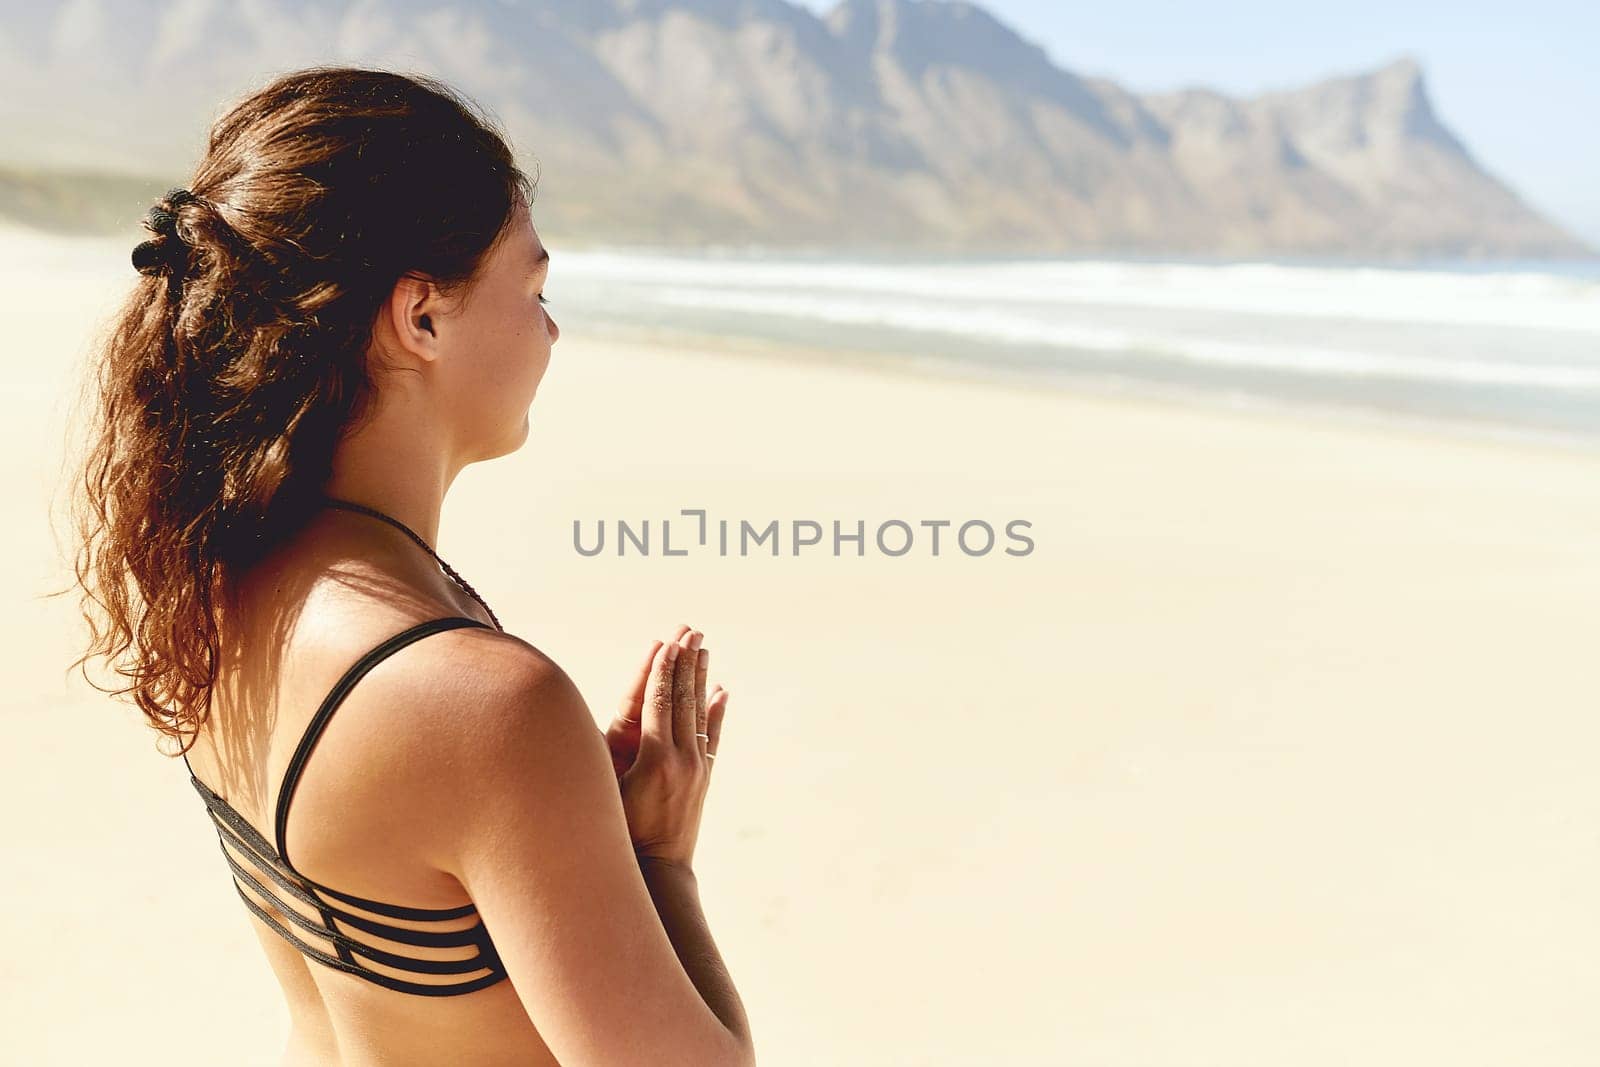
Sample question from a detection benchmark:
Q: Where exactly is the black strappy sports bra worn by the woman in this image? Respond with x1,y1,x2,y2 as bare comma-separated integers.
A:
184,616,506,997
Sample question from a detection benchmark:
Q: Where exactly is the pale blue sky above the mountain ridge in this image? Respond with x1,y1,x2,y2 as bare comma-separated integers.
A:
803,0,1600,245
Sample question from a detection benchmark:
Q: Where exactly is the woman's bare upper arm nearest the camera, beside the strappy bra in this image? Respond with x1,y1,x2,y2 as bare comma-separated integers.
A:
416,640,742,1065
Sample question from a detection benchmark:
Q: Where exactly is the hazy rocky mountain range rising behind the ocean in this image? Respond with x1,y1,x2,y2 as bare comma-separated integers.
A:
0,0,1589,258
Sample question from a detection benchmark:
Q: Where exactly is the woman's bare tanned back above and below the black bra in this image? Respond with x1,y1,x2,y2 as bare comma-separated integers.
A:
190,531,557,1067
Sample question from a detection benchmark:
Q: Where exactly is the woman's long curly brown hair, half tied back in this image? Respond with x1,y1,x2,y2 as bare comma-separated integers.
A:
58,66,536,755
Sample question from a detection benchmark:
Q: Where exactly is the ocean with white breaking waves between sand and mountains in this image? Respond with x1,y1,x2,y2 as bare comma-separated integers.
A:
544,252,1600,450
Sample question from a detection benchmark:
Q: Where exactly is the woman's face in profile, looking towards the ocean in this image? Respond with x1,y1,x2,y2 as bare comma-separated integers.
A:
442,205,562,458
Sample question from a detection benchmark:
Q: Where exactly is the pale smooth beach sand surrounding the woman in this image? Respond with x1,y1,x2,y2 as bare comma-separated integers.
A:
0,230,1600,1067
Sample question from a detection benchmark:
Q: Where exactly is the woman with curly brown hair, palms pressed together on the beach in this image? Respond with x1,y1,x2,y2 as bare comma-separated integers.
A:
62,67,754,1067
